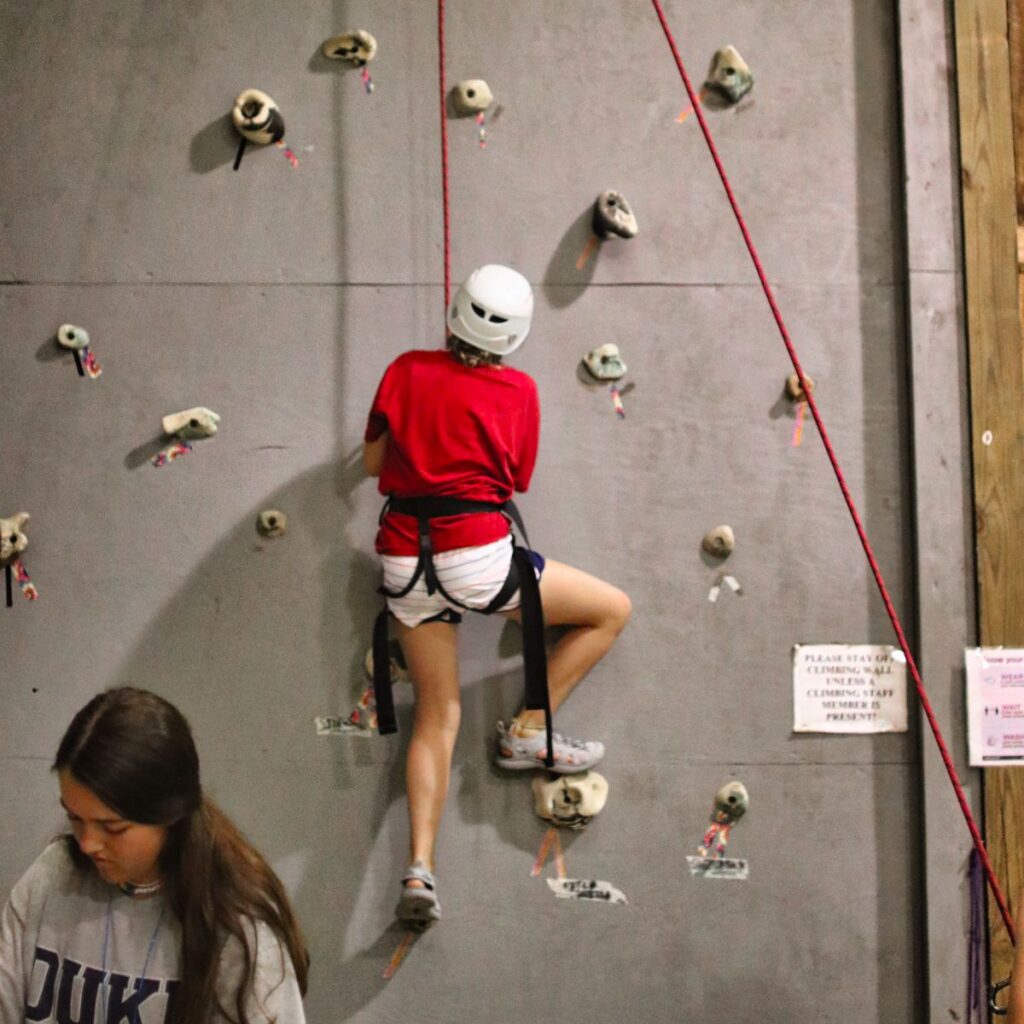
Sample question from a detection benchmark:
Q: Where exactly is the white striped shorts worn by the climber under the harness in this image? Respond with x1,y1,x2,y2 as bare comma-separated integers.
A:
380,535,544,627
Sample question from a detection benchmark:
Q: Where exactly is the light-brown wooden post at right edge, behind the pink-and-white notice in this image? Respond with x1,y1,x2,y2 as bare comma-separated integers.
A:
950,0,1024,979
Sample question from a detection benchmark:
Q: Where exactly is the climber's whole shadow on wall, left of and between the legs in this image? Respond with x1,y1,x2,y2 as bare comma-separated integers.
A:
112,453,538,1020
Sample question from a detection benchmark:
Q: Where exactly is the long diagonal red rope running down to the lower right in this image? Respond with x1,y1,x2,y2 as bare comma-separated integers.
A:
651,0,1017,944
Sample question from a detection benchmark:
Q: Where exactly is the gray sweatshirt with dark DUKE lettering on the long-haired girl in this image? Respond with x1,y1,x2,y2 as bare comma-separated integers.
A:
0,841,305,1024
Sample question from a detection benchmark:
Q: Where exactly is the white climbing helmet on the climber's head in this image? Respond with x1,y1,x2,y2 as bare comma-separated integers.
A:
449,263,534,355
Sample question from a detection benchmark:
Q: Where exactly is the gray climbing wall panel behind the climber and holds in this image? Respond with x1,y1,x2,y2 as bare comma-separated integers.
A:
0,0,974,1024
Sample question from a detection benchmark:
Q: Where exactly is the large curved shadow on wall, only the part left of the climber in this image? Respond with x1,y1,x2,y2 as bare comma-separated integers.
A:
105,455,401,1019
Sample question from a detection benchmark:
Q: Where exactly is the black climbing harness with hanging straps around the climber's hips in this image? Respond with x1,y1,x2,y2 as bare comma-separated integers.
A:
374,497,555,768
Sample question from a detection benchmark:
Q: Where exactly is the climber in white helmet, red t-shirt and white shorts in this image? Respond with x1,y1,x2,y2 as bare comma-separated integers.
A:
364,265,631,925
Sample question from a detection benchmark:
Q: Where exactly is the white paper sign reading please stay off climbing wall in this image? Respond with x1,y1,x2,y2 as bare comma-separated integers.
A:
793,644,906,733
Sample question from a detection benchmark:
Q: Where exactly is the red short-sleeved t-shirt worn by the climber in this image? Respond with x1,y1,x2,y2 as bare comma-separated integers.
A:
365,349,541,555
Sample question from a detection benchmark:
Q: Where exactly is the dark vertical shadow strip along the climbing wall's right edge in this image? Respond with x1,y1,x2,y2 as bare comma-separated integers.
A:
847,3,929,1019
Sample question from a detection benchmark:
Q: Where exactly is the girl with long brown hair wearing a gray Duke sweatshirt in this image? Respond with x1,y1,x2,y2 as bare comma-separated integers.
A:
0,687,309,1024
